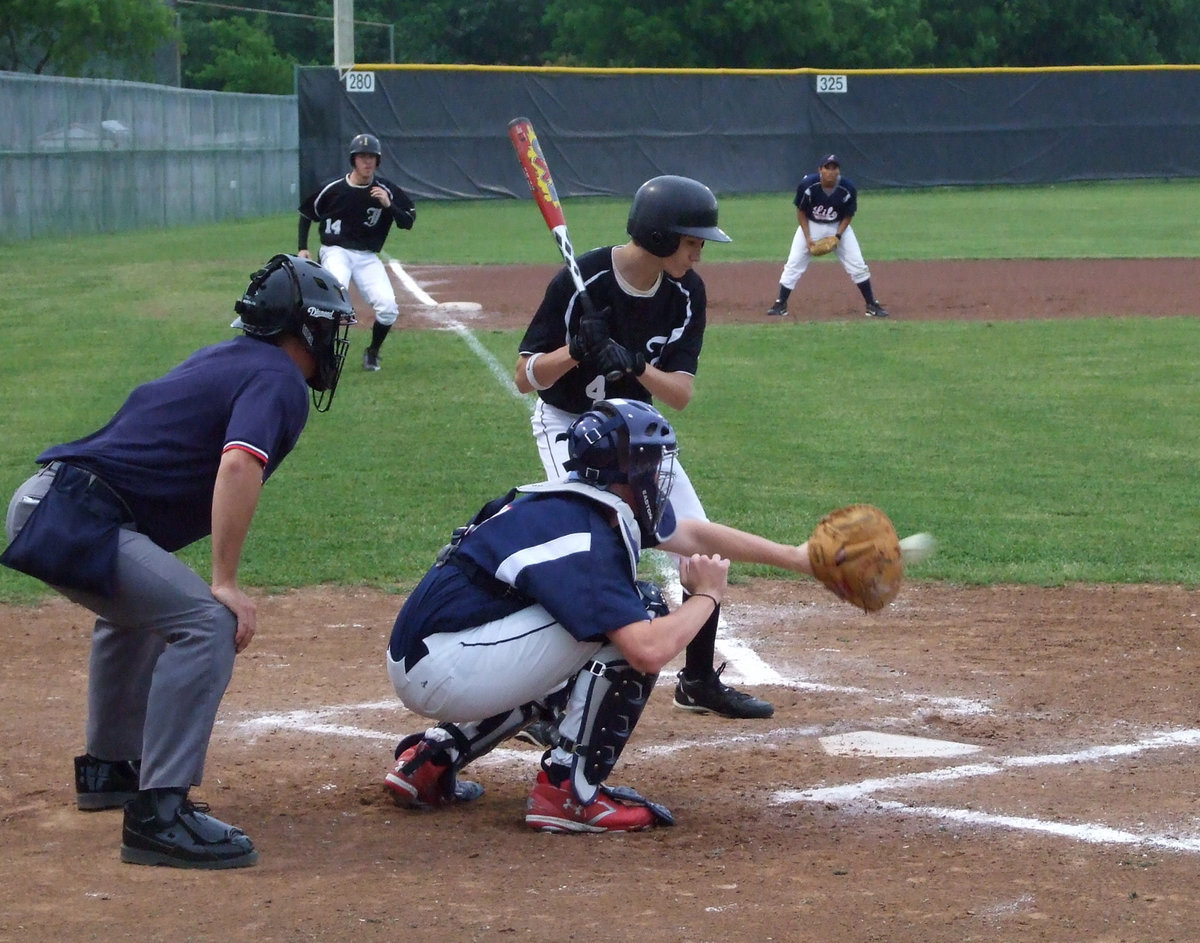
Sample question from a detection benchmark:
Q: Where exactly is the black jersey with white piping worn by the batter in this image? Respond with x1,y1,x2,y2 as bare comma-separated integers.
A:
520,246,708,413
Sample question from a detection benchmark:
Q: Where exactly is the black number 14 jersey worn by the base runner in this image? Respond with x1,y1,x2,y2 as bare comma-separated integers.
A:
299,174,416,252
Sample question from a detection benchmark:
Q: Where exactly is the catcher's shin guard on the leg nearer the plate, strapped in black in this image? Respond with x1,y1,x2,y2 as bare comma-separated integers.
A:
552,645,658,805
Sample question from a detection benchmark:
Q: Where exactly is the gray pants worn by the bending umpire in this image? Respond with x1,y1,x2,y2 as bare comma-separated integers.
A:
5,469,238,789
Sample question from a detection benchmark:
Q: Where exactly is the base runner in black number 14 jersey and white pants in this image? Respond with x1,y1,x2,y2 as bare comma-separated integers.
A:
296,134,416,371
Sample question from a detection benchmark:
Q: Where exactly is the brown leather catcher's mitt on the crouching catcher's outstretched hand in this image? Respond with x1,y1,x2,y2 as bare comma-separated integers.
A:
809,504,904,612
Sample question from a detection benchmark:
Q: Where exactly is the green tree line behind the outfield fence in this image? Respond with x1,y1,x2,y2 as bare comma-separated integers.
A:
7,0,1200,95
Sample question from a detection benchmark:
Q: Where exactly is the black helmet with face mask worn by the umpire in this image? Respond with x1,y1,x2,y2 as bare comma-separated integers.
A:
232,256,355,413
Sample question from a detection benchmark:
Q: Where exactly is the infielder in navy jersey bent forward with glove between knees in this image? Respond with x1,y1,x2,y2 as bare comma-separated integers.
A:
767,154,888,318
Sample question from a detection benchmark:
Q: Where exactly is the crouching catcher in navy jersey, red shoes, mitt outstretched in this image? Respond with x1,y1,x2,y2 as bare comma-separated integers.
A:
385,400,904,831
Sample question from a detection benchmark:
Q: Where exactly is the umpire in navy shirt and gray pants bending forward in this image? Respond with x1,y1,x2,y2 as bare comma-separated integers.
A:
0,256,354,869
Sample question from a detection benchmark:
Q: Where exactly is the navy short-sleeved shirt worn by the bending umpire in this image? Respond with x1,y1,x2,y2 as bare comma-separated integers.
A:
37,336,308,551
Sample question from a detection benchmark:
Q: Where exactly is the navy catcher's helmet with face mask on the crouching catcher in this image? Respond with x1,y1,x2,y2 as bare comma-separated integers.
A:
564,400,678,542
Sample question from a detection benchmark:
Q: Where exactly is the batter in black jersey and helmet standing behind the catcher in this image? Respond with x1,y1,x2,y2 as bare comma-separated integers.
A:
515,176,774,729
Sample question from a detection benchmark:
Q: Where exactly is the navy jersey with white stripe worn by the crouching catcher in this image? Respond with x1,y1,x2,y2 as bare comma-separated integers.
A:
389,482,674,661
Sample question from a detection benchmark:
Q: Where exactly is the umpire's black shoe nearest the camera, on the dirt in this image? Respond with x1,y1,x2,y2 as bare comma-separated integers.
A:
121,789,258,870
